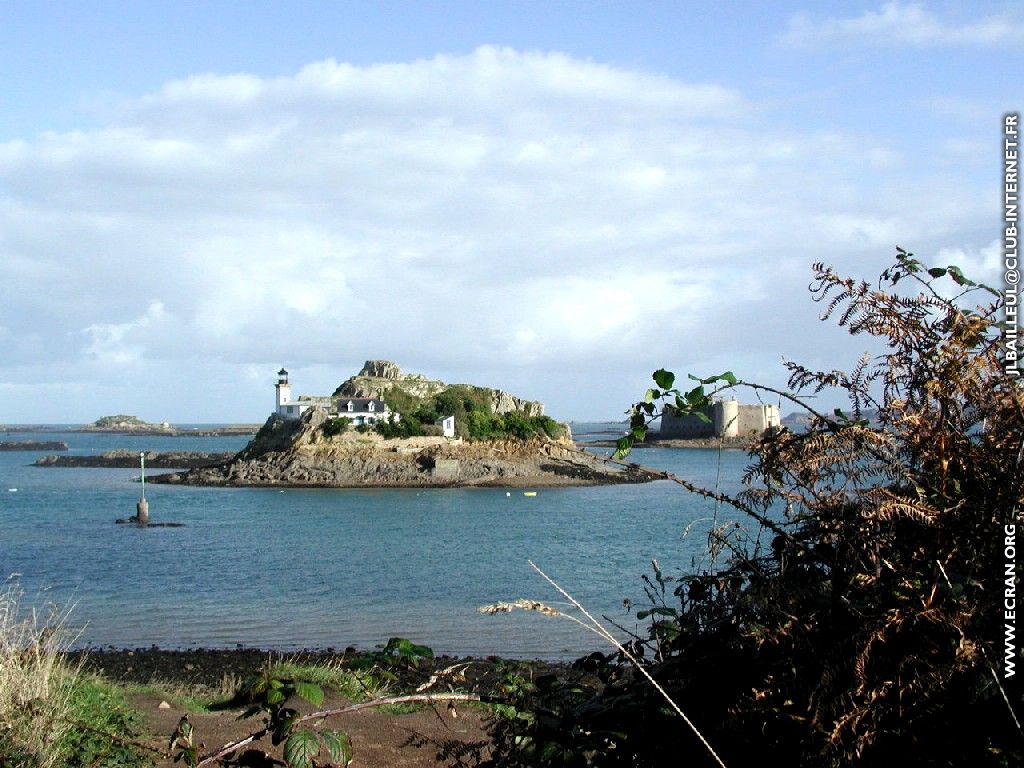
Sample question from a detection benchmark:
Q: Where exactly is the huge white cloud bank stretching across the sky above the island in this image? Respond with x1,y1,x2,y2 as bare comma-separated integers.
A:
0,47,988,421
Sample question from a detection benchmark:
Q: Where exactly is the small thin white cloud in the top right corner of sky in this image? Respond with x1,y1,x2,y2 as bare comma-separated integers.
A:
782,2,1024,48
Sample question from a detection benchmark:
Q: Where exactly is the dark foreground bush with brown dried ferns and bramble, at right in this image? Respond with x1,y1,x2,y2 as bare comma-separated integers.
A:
481,250,1024,768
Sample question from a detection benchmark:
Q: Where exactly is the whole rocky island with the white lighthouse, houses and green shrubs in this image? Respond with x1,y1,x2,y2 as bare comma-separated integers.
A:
152,360,658,487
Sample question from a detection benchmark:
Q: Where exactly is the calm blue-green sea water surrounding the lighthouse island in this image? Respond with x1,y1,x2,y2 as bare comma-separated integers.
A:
0,424,746,658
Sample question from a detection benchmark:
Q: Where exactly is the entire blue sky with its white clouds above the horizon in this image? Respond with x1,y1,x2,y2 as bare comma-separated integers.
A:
0,0,1024,424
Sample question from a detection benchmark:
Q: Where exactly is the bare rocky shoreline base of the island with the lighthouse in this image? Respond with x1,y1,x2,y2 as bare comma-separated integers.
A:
152,408,658,487
